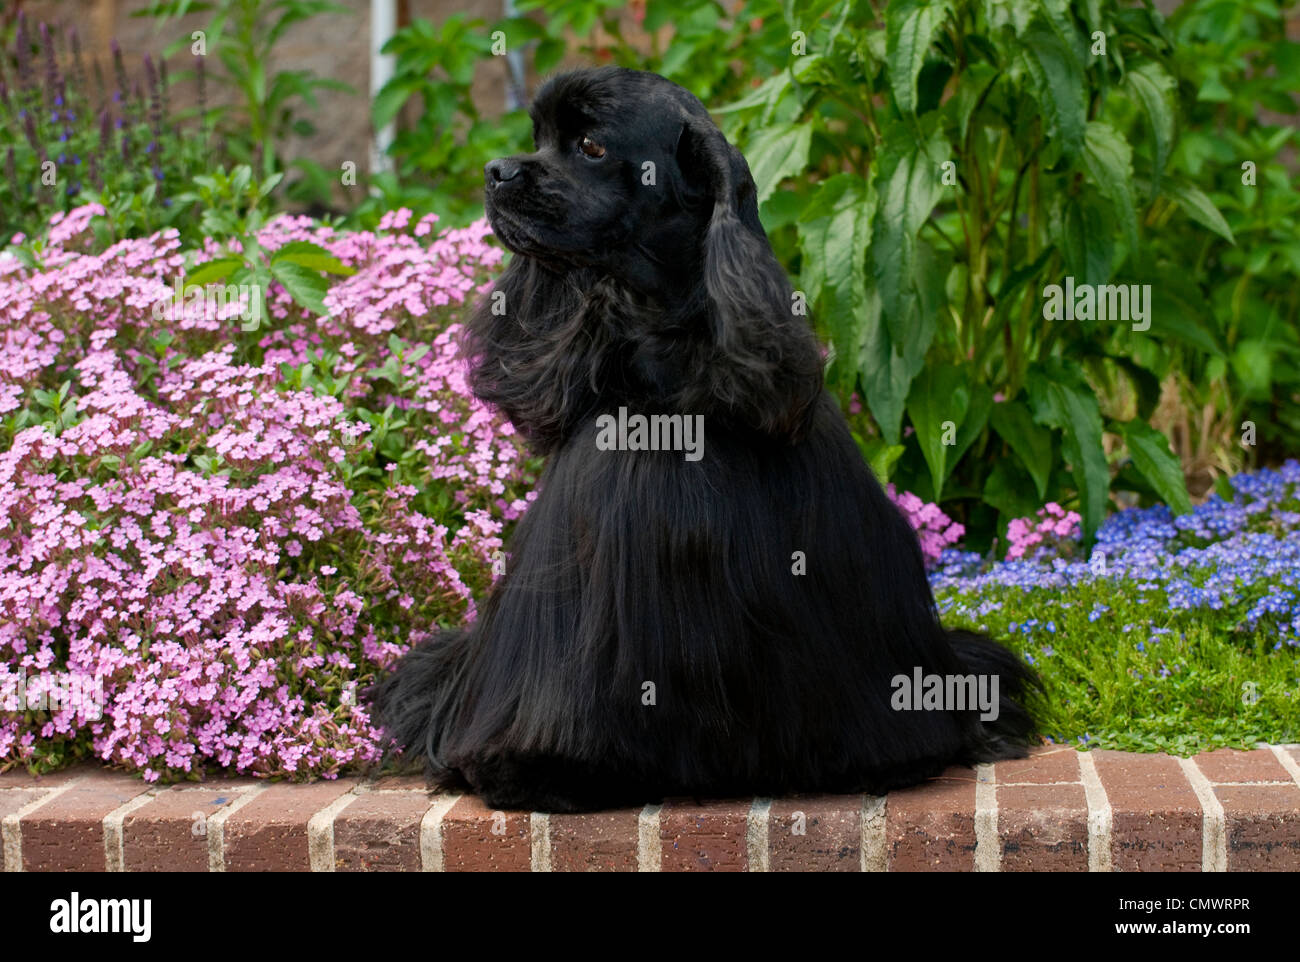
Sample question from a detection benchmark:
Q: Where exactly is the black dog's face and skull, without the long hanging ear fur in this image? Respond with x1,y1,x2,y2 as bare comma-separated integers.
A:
484,68,766,295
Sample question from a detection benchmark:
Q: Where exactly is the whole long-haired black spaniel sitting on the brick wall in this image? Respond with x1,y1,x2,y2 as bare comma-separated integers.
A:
367,68,1036,811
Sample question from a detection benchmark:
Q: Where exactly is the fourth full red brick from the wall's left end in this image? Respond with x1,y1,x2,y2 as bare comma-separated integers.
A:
334,789,432,872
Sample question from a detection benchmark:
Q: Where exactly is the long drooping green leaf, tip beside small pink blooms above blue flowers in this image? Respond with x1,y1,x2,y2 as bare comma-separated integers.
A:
1026,358,1110,540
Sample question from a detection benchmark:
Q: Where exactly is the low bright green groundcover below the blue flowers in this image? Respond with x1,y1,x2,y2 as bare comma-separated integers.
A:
937,590,1300,755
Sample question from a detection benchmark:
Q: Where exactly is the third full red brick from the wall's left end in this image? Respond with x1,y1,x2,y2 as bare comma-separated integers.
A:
224,779,356,872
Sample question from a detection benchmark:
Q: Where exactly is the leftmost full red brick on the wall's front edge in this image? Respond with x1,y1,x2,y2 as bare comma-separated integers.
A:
21,771,150,872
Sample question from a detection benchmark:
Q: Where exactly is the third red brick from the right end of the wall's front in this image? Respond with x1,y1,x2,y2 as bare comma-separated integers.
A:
997,780,1088,872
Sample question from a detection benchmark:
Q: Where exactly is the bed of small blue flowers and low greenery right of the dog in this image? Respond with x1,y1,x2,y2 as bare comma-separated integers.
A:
932,460,1300,753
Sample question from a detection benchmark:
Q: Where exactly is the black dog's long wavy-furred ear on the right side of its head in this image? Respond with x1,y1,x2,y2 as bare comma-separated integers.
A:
677,116,822,438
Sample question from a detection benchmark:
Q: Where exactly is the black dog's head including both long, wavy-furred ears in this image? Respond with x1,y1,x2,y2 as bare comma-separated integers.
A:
468,68,822,450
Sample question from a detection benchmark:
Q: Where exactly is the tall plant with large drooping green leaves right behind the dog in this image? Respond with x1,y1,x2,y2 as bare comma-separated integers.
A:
718,0,1216,545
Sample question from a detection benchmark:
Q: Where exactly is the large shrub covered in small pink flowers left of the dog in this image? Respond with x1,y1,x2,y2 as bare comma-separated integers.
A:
0,207,536,780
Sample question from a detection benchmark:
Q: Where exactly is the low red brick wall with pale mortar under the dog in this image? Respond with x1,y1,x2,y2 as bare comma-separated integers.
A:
0,746,1300,872
